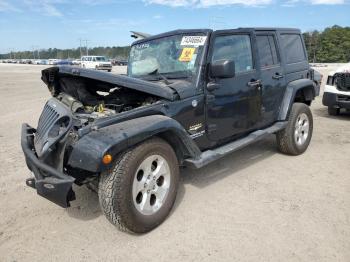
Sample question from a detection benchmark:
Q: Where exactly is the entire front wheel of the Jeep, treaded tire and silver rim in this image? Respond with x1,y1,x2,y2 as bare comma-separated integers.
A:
99,138,179,233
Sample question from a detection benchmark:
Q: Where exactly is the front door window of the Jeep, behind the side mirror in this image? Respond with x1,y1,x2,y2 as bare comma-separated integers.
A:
212,35,253,73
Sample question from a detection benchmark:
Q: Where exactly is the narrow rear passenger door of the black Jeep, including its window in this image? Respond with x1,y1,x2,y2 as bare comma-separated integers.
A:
256,31,286,127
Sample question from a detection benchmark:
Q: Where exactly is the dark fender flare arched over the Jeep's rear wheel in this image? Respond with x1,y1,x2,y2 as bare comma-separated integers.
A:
278,79,316,121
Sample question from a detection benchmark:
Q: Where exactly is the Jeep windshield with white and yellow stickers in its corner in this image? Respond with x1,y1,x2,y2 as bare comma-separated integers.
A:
128,34,206,78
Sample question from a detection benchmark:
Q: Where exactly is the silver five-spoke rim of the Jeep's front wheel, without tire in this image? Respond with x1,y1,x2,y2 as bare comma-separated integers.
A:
132,155,170,215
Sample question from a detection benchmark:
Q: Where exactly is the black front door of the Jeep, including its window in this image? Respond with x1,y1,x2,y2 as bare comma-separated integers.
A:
206,30,261,141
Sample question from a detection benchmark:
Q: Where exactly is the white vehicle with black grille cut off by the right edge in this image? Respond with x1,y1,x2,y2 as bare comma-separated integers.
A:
322,63,350,115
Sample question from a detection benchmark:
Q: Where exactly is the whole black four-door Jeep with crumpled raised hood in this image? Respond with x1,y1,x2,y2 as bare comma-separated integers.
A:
22,28,317,233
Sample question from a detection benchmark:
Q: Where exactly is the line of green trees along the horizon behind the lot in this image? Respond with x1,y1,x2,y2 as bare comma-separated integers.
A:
0,25,350,63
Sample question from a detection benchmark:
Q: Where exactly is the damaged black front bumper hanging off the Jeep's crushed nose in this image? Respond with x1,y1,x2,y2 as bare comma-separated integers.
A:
21,124,75,207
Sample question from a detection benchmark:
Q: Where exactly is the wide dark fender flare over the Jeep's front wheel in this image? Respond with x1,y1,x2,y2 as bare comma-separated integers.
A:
68,115,201,173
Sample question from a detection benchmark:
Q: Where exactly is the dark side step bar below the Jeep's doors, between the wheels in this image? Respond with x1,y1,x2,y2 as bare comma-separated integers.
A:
184,121,288,168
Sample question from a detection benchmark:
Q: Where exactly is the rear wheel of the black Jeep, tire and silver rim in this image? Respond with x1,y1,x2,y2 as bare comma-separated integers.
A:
276,103,313,155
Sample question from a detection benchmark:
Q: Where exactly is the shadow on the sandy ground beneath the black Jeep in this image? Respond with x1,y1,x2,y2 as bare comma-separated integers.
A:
67,135,277,221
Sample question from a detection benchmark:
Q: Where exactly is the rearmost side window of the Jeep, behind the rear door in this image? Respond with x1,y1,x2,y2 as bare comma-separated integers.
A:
281,34,306,64
